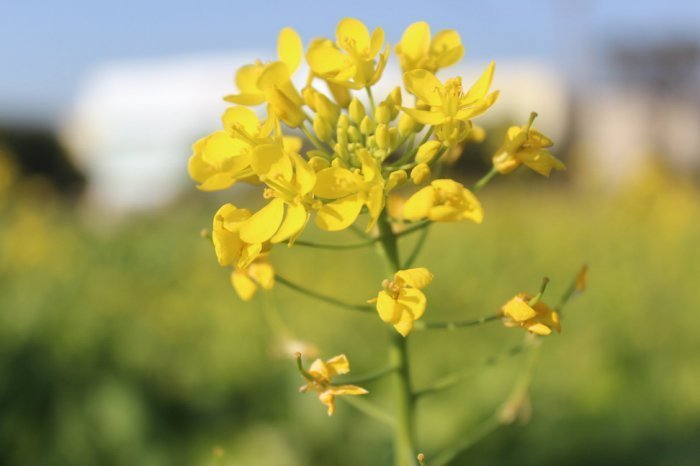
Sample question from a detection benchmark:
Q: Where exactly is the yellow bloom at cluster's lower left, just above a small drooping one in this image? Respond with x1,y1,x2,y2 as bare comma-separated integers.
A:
212,204,262,269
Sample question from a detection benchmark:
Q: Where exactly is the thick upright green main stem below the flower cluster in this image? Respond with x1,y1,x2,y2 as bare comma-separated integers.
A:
377,210,416,466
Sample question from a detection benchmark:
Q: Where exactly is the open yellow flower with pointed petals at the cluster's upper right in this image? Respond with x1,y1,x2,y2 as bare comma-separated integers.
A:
401,62,498,126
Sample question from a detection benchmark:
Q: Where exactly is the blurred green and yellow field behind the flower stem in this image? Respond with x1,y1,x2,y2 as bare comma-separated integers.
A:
0,175,700,466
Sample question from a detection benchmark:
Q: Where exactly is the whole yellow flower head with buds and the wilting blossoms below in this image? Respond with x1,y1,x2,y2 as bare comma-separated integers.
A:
188,18,564,414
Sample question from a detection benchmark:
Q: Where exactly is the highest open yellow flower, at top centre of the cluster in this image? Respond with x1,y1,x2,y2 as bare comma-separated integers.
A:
306,18,389,89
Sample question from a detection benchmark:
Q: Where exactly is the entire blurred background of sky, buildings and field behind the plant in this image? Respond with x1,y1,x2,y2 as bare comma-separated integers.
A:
0,0,700,466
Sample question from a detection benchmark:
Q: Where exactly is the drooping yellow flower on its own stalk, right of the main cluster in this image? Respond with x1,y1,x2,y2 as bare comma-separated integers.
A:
493,112,566,176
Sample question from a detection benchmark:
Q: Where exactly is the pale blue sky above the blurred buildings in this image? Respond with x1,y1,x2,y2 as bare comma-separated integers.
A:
0,0,700,125
